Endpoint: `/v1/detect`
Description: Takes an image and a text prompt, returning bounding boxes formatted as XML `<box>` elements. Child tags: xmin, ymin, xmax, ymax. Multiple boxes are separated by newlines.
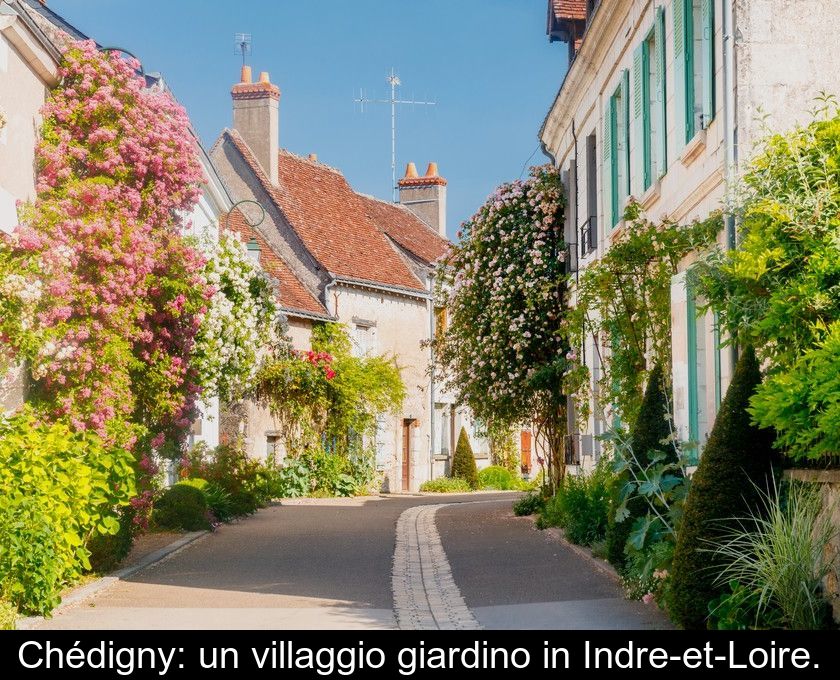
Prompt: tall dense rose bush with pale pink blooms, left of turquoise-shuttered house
<box><xmin>434</xmin><ymin>166</ymin><xmax>569</xmax><ymax>479</ymax></box>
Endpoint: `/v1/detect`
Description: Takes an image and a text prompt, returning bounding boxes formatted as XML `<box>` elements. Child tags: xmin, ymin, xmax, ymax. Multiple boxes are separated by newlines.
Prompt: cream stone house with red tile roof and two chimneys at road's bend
<box><xmin>210</xmin><ymin>67</ymin><xmax>487</xmax><ymax>492</ymax></box>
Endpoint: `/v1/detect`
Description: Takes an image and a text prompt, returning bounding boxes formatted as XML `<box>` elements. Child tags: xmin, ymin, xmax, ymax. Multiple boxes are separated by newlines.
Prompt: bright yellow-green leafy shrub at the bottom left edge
<box><xmin>0</xmin><ymin>409</ymin><xmax>134</xmax><ymax>614</ymax></box>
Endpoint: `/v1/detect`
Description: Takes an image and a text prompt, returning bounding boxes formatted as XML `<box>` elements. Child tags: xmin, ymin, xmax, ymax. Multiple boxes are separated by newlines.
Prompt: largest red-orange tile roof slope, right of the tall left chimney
<box><xmin>225</xmin><ymin>130</ymin><xmax>425</xmax><ymax>291</ymax></box>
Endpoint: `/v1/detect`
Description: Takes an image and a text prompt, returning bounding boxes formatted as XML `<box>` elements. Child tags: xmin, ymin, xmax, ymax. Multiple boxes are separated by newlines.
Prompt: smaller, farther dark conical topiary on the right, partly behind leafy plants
<box><xmin>607</xmin><ymin>365</ymin><xmax>676</xmax><ymax>569</ymax></box>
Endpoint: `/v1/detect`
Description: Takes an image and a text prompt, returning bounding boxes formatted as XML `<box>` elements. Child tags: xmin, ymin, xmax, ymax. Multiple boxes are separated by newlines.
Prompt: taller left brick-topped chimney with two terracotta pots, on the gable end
<box><xmin>230</xmin><ymin>66</ymin><xmax>280</xmax><ymax>184</ymax></box>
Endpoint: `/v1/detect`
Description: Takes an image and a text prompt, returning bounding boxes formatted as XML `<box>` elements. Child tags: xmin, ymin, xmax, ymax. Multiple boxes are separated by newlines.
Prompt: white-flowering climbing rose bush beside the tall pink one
<box><xmin>193</xmin><ymin>231</ymin><xmax>285</xmax><ymax>402</ymax></box>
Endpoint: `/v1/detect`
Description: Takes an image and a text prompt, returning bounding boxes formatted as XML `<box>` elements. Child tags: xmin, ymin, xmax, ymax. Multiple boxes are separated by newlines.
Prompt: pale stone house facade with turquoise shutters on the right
<box><xmin>539</xmin><ymin>0</ymin><xmax>840</xmax><ymax>465</ymax></box>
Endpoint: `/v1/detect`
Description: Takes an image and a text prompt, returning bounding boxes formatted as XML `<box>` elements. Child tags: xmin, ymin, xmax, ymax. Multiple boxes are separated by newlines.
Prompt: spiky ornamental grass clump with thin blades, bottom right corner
<box><xmin>706</xmin><ymin>482</ymin><xmax>837</xmax><ymax>630</ymax></box>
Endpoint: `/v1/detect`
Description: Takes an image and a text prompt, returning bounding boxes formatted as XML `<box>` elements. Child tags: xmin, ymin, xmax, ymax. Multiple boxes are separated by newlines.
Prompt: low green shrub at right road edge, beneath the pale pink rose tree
<box><xmin>540</xmin><ymin>458</ymin><xmax>613</xmax><ymax>545</ymax></box>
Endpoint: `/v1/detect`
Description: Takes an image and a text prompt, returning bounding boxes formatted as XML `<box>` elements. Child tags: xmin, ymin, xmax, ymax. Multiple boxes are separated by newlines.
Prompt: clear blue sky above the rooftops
<box><xmin>49</xmin><ymin>0</ymin><xmax>566</xmax><ymax>236</ymax></box>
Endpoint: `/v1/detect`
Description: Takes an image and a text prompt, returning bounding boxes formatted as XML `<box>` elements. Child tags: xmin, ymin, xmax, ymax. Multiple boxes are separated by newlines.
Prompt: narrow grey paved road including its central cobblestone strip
<box><xmin>41</xmin><ymin>494</ymin><xmax>665</xmax><ymax>629</ymax></box>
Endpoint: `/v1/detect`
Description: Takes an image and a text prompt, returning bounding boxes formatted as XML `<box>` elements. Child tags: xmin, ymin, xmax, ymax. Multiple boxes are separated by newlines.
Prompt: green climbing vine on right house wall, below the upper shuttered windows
<box><xmin>566</xmin><ymin>203</ymin><xmax>721</xmax><ymax>423</ymax></box>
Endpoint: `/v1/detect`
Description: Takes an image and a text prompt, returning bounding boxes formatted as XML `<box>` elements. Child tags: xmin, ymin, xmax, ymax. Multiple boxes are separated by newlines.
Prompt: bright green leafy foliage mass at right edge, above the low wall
<box><xmin>698</xmin><ymin>100</ymin><xmax>840</xmax><ymax>460</ymax></box>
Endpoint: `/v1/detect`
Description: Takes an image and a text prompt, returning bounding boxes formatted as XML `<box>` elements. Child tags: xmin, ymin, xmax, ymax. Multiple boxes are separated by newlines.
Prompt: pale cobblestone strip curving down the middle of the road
<box><xmin>391</xmin><ymin>504</ymin><xmax>481</xmax><ymax>630</ymax></box>
